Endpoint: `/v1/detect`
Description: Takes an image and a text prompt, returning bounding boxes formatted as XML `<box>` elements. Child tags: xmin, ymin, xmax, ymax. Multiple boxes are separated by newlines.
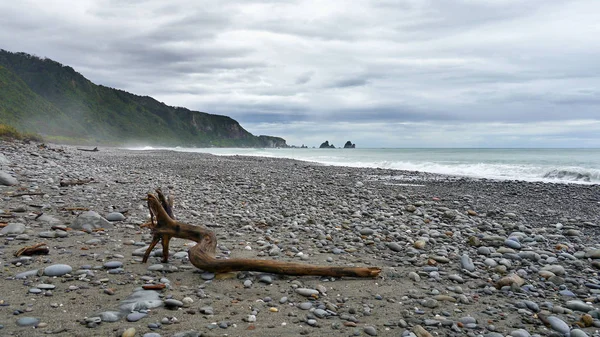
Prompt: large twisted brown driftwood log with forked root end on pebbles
<box><xmin>141</xmin><ymin>189</ymin><xmax>381</xmax><ymax>278</ymax></box>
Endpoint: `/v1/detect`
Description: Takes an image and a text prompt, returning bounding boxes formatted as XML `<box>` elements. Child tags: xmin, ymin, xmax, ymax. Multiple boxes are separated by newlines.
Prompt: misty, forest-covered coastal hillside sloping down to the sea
<box><xmin>0</xmin><ymin>50</ymin><xmax>287</xmax><ymax>147</ymax></box>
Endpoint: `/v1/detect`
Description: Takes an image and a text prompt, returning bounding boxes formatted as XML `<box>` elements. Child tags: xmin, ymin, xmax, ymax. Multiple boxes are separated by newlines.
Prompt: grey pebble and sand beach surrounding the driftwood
<box><xmin>0</xmin><ymin>142</ymin><xmax>600</xmax><ymax>337</ymax></box>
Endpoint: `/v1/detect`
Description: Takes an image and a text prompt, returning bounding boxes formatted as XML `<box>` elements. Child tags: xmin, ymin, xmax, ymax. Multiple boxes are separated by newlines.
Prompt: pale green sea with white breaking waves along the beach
<box><xmin>131</xmin><ymin>147</ymin><xmax>600</xmax><ymax>184</ymax></box>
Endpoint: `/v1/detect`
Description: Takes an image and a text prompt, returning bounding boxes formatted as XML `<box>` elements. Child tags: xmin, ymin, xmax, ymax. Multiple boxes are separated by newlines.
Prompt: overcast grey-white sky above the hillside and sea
<box><xmin>0</xmin><ymin>0</ymin><xmax>600</xmax><ymax>147</ymax></box>
